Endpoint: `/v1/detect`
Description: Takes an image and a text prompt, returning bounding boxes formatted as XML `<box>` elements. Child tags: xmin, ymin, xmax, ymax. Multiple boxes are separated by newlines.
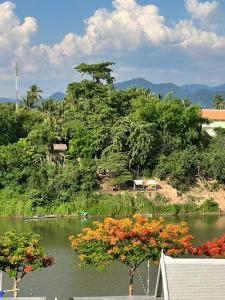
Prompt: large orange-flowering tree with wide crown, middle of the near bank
<box><xmin>69</xmin><ymin>215</ymin><xmax>193</xmax><ymax>295</ymax></box>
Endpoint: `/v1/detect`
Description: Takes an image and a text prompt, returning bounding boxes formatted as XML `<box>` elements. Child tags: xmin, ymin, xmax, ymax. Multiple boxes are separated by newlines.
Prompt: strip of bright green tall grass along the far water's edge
<box><xmin>0</xmin><ymin>189</ymin><xmax>220</xmax><ymax>217</ymax></box>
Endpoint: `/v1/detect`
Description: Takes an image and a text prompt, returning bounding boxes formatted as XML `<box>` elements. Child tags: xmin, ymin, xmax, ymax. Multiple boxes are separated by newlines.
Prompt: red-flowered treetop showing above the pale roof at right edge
<box><xmin>192</xmin><ymin>234</ymin><xmax>225</xmax><ymax>258</ymax></box>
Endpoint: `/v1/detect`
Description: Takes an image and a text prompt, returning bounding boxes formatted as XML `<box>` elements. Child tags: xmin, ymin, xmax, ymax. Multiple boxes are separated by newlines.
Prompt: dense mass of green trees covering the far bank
<box><xmin>0</xmin><ymin>62</ymin><xmax>225</xmax><ymax>216</ymax></box>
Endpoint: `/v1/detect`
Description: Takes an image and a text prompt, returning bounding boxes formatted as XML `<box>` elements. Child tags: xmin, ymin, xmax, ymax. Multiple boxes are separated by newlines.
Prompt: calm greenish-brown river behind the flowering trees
<box><xmin>0</xmin><ymin>216</ymin><xmax>225</xmax><ymax>300</ymax></box>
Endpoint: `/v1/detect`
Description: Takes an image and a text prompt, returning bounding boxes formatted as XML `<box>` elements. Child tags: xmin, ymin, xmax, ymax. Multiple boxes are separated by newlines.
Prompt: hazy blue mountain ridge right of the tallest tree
<box><xmin>115</xmin><ymin>78</ymin><xmax>225</xmax><ymax>108</ymax></box>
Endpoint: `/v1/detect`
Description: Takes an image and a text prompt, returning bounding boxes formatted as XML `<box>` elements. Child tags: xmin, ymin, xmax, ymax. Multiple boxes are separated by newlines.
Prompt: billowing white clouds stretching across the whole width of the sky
<box><xmin>0</xmin><ymin>0</ymin><xmax>225</xmax><ymax>84</ymax></box>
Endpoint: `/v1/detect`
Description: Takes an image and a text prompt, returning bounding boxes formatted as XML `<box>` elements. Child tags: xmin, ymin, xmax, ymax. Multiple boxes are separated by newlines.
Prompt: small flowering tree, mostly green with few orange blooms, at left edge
<box><xmin>0</xmin><ymin>231</ymin><xmax>53</xmax><ymax>298</ymax></box>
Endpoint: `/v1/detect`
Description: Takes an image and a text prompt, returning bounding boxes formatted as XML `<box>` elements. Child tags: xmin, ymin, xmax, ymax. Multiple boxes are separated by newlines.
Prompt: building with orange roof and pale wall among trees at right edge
<box><xmin>202</xmin><ymin>109</ymin><xmax>225</xmax><ymax>136</ymax></box>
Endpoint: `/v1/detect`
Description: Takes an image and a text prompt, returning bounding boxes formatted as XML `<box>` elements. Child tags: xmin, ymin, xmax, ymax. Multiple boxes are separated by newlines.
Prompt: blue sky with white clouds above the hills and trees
<box><xmin>0</xmin><ymin>0</ymin><xmax>225</xmax><ymax>97</ymax></box>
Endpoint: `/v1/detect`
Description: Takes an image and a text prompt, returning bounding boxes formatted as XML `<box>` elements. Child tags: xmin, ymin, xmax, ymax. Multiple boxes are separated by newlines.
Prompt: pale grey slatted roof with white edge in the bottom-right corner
<box><xmin>155</xmin><ymin>253</ymin><xmax>225</xmax><ymax>300</ymax></box>
